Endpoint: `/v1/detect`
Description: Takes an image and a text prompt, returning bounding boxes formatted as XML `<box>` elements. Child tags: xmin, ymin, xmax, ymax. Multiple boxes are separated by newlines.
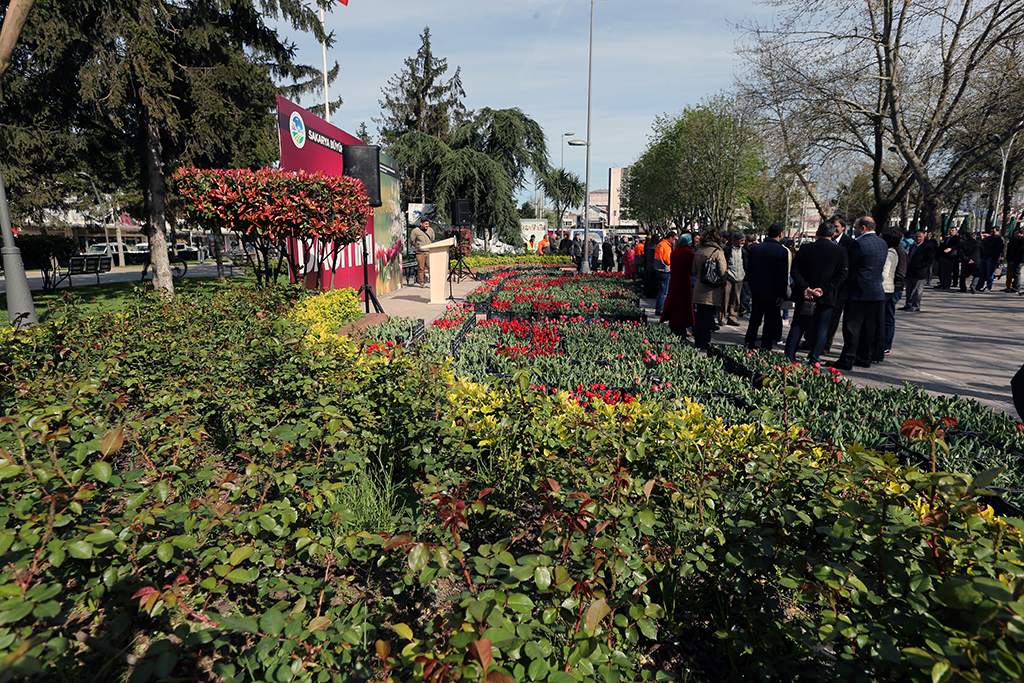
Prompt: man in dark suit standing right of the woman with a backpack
<box><xmin>743</xmin><ymin>223</ymin><xmax>790</xmax><ymax>351</ymax></box>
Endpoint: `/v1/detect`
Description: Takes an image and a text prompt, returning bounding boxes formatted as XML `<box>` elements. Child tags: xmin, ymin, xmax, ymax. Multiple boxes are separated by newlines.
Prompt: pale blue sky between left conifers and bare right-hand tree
<box><xmin>276</xmin><ymin>0</ymin><xmax>769</xmax><ymax>199</ymax></box>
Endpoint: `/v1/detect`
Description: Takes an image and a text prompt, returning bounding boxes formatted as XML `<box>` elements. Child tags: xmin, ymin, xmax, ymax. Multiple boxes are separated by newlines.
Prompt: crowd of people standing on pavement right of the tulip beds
<box><xmin>634</xmin><ymin>216</ymin><xmax>1024</xmax><ymax>371</ymax></box>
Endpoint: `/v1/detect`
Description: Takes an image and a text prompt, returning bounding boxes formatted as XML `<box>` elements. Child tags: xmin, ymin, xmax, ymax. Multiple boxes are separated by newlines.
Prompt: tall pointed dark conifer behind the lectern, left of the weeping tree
<box><xmin>373</xmin><ymin>27</ymin><xmax>468</xmax><ymax>208</ymax></box>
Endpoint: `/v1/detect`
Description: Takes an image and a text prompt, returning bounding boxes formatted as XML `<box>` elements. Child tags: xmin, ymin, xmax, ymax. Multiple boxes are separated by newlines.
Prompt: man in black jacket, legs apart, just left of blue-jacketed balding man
<box><xmin>785</xmin><ymin>222</ymin><xmax>849</xmax><ymax>362</ymax></box>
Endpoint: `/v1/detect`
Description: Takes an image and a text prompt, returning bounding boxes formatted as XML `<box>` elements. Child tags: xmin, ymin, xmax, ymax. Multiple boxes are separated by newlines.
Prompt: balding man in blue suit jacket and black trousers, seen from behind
<box><xmin>833</xmin><ymin>216</ymin><xmax>888</xmax><ymax>371</ymax></box>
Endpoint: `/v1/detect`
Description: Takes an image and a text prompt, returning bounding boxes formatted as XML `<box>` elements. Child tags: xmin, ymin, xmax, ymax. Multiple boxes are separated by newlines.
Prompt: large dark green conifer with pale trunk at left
<box><xmin>2</xmin><ymin>0</ymin><xmax>327</xmax><ymax>294</ymax></box>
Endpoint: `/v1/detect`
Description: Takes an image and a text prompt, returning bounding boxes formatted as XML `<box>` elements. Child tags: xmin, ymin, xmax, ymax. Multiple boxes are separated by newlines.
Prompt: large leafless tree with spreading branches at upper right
<box><xmin>741</xmin><ymin>0</ymin><xmax>1024</xmax><ymax>228</ymax></box>
